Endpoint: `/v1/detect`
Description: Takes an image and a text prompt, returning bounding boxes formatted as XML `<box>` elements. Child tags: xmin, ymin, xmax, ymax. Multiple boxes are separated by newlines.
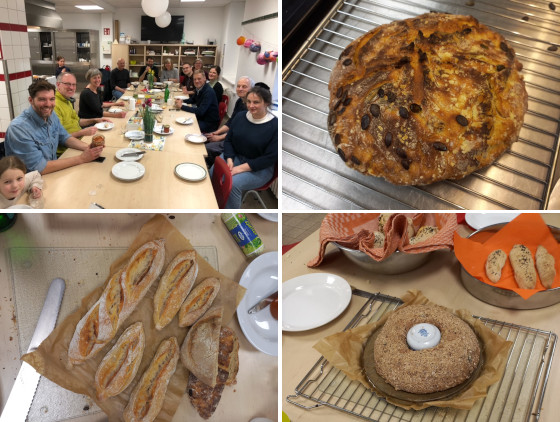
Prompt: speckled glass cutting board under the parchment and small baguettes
<box><xmin>8</xmin><ymin>246</ymin><xmax>218</xmax><ymax>422</ymax></box>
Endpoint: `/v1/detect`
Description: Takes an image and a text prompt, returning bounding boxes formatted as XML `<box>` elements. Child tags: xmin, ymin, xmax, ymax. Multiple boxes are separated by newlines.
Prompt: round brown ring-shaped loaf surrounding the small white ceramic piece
<box><xmin>374</xmin><ymin>305</ymin><xmax>480</xmax><ymax>394</ymax></box>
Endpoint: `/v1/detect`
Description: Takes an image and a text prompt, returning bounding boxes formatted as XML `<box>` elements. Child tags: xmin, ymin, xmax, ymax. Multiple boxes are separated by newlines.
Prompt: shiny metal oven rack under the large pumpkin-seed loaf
<box><xmin>282</xmin><ymin>0</ymin><xmax>560</xmax><ymax>209</ymax></box>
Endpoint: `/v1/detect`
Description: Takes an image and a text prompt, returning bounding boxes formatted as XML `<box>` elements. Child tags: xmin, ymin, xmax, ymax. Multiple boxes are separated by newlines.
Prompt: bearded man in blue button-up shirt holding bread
<box><xmin>4</xmin><ymin>80</ymin><xmax>103</xmax><ymax>174</ymax></box>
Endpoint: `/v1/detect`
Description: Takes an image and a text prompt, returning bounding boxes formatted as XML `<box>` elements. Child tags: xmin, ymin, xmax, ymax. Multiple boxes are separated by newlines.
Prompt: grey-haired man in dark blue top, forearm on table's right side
<box><xmin>175</xmin><ymin>70</ymin><xmax>220</xmax><ymax>133</ymax></box>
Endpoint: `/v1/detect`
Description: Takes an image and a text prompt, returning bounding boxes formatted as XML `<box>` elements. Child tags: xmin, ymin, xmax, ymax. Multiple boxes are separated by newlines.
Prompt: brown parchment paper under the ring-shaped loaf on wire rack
<box><xmin>313</xmin><ymin>290</ymin><xmax>513</xmax><ymax>410</ymax></box>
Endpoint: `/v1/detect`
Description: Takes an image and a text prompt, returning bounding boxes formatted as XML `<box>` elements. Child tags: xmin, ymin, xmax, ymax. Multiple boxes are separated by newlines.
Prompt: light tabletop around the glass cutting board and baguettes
<box><xmin>0</xmin><ymin>213</ymin><xmax>278</xmax><ymax>422</ymax></box>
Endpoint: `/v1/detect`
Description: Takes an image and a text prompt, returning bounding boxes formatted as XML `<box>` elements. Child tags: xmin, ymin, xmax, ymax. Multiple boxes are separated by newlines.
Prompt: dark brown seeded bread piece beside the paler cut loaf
<box><xmin>187</xmin><ymin>327</ymin><xmax>239</xmax><ymax>419</ymax></box>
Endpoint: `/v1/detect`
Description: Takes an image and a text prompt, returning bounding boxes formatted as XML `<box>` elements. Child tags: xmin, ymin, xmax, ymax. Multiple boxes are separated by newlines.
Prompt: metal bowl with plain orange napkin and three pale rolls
<box><xmin>461</xmin><ymin>223</ymin><xmax>560</xmax><ymax>309</ymax></box>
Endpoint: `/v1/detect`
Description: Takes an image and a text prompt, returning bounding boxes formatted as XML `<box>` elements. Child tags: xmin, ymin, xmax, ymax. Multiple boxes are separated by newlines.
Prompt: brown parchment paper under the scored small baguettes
<box><xmin>22</xmin><ymin>215</ymin><xmax>245</xmax><ymax>422</ymax></box>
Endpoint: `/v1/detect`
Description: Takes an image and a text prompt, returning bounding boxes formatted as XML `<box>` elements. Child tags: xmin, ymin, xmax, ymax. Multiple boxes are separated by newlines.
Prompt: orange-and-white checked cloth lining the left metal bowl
<box><xmin>307</xmin><ymin>213</ymin><xmax>457</xmax><ymax>267</ymax></box>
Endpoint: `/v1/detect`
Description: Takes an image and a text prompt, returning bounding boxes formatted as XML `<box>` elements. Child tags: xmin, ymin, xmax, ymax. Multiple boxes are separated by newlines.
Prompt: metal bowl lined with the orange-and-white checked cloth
<box><xmin>333</xmin><ymin>242</ymin><xmax>432</xmax><ymax>274</ymax></box>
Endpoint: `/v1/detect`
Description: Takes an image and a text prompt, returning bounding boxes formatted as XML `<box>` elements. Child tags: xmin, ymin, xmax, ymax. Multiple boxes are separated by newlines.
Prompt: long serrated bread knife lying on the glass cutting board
<box><xmin>0</xmin><ymin>278</ymin><xmax>66</xmax><ymax>422</ymax></box>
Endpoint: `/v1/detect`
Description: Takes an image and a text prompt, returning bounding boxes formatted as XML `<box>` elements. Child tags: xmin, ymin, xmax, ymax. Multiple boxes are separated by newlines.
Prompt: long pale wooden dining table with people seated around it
<box><xmin>19</xmin><ymin>85</ymin><xmax>218</xmax><ymax>209</ymax></box>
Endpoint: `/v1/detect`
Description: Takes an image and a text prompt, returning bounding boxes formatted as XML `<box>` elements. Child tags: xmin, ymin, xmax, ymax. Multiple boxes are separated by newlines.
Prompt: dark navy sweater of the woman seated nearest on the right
<box><xmin>224</xmin><ymin>113</ymin><xmax>278</xmax><ymax>171</ymax></box>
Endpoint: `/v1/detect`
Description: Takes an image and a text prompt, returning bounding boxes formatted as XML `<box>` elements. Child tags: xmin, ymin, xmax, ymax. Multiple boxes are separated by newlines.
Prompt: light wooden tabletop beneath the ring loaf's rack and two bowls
<box><xmin>281</xmin><ymin>214</ymin><xmax>560</xmax><ymax>422</ymax></box>
